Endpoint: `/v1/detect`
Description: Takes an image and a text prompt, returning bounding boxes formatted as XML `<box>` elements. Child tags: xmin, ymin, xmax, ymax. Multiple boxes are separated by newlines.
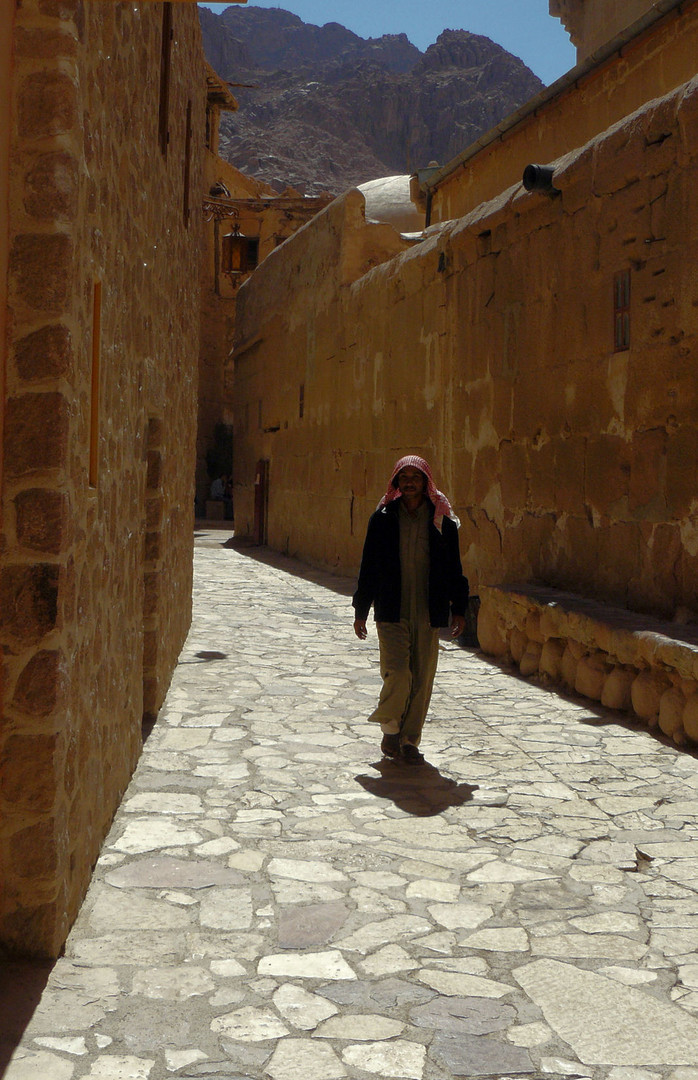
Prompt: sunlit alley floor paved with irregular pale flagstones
<box><xmin>0</xmin><ymin>531</ymin><xmax>698</xmax><ymax>1080</ymax></box>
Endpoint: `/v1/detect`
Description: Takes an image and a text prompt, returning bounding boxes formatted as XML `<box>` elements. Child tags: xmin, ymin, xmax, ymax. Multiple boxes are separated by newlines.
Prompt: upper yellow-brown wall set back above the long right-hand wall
<box><xmin>431</xmin><ymin>4</ymin><xmax>698</xmax><ymax>221</ymax></box>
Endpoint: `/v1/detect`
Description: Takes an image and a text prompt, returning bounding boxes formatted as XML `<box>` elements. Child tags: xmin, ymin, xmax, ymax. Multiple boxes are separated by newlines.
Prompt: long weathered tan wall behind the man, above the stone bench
<box><xmin>236</xmin><ymin>80</ymin><xmax>698</xmax><ymax>617</ymax></box>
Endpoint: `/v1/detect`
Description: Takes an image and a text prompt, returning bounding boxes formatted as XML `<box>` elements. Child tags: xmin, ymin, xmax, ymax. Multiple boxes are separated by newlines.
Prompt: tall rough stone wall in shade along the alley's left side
<box><xmin>0</xmin><ymin>0</ymin><xmax>205</xmax><ymax>956</ymax></box>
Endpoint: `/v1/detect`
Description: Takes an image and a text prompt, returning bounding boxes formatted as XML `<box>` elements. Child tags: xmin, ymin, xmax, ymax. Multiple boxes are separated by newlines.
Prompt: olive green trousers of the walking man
<box><xmin>368</xmin><ymin>619</ymin><xmax>439</xmax><ymax>746</ymax></box>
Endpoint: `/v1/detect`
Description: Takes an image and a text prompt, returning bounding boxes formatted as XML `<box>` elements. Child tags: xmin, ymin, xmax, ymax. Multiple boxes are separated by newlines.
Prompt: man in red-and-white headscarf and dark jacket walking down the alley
<box><xmin>352</xmin><ymin>455</ymin><xmax>468</xmax><ymax>765</ymax></box>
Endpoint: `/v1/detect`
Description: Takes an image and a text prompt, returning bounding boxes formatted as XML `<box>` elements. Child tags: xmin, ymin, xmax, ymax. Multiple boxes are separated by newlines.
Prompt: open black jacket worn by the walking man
<box><xmin>352</xmin><ymin>499</ymin><xmax>468</xmax><ymax>626</ymax></box>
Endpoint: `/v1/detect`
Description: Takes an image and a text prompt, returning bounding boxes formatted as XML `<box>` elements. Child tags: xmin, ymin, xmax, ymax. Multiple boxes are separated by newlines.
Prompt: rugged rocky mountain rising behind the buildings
<box><xmin>199</xmin><ymin>5</ymin><xmax>542</xmax><ymax>194</ymax></box>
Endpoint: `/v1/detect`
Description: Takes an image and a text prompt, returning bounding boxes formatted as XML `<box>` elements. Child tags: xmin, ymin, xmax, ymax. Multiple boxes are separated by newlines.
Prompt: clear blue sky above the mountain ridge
<box><xmin>198</xmin><ymin>0</ymin><xmax>575</xmax><ymax>84</ymax></box>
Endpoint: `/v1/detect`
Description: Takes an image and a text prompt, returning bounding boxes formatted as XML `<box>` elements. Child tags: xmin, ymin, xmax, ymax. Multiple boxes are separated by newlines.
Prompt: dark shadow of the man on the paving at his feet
<box><xmin>354</xmin><ymin>757</ymin><xmax>478</xmax><ymax>818</ymax></box>
